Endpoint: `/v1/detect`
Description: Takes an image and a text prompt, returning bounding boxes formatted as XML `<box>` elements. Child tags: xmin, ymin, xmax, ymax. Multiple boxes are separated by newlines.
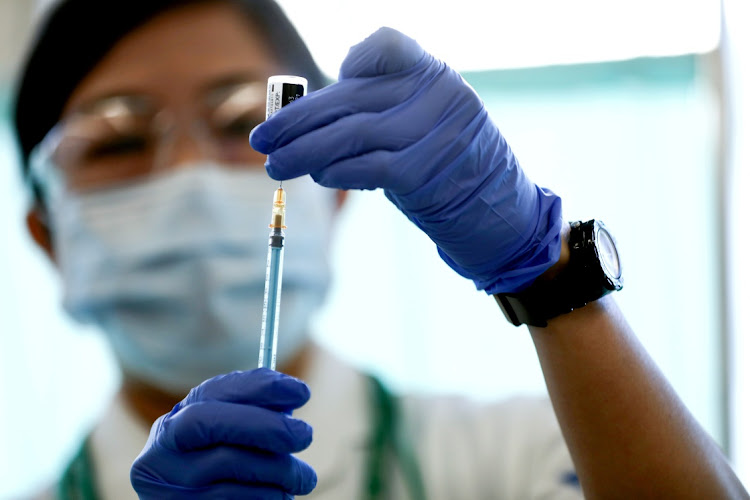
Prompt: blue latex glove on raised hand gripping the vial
<box><xmin>250</xmin><ymin>28</ymin><xmax>562</xmax><ymax>293</ymax></box>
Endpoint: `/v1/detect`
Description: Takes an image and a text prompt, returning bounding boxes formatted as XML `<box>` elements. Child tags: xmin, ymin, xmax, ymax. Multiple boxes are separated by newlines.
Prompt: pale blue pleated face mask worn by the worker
<box><xmin>50</xmin><ymin>165</ymin><xmax>335</xmax><ymax>393</ymax></box>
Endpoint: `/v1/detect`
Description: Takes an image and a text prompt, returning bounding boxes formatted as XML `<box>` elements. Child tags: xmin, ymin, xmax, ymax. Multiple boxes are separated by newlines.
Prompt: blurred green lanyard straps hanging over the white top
<box><xmin>57</xmin><ymin>377</ymin><xmax>427</xmax><ymax>500</ymax></box>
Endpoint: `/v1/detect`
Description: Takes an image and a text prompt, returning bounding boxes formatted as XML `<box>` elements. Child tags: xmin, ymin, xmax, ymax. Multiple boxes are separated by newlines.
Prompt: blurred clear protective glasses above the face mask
<box><xmin>30</xmin><ymin>81</ymin><xmax>266</xmax><ymax>192</ymax></box>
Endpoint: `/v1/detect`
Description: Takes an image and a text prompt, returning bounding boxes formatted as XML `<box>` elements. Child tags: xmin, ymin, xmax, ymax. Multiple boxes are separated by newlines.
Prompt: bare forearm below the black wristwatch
<box><xmin>530</xmin><ymin>297</ymin><xmax>748</xmax><ymax>499</ymax></box>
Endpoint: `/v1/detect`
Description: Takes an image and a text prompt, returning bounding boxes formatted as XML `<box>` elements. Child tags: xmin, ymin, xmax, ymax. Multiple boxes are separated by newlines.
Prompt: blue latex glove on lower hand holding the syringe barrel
<box><xmin>130</xmin><ymin>368</ymin><xmax>317</xmax><ymax>499</ymax></box>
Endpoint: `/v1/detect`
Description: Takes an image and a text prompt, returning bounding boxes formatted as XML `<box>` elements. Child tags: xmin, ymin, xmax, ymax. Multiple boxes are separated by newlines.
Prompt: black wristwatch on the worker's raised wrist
<box><xmin>495</xmin><ymin>220</ymin><xmax>622</xmax><ymax>327</ymax></box>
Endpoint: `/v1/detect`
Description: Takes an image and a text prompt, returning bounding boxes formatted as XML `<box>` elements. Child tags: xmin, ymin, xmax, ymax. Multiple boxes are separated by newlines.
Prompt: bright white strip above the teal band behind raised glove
<box><xmin>278</xmin><ymin>0</ymin><xmax>720</xmax><ymax>76</ymax></box>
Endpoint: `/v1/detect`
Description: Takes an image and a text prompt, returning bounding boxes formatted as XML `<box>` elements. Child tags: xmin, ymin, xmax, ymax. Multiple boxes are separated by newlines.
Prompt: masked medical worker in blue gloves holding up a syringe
<box><xmin>14</xmin><ymin>0</ymin><xmax>747</xmax><ymax>500</ymax></box>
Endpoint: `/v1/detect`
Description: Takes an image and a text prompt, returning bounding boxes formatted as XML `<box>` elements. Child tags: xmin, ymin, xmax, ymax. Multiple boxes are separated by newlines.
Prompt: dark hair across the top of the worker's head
<box><xmin>13</xmin><ymin>0</ymin><xmax>327</xmax><ymax>205</ymax></box>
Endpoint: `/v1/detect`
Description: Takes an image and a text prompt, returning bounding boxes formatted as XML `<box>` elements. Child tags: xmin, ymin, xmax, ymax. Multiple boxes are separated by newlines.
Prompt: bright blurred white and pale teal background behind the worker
<box><xmin>0</xmin><ymin>0</ymin><xmax>750</xmax><ymax>499</ymax></box>
